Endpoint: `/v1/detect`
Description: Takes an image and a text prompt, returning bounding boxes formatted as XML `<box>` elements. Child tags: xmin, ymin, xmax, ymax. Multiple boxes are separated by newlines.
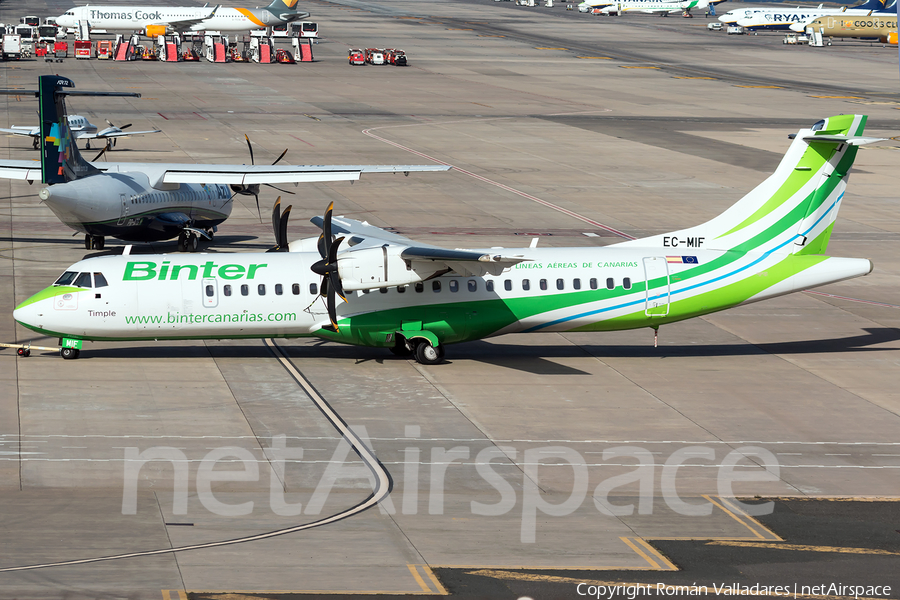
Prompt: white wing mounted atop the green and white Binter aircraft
<box><xmin>310</xmin><ymin>217</ymin><xmax>532</xmax><ymax>277</ymax></box>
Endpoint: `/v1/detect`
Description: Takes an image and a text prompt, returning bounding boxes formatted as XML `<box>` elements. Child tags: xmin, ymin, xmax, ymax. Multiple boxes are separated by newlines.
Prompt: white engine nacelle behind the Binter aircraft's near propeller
<box><xmin>338</xmin><ymin>246</ymin><xmax>445</xmax><ymax>292</ymax></box>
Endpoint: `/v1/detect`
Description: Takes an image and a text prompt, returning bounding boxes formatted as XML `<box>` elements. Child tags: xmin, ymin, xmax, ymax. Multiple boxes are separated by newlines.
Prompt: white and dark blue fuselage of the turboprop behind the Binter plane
<box><xmin>39</xmin><ymin>171</ymin><xmax>232</xmax><ymax>242</ymax></box>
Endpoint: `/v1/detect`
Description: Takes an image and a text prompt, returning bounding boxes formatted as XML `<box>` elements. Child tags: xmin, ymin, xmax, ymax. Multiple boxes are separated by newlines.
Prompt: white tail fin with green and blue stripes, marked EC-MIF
<box><xmin>617</xmin><ymin>115</ymin><xmax>881</xmax><ymax>254</ymax></box>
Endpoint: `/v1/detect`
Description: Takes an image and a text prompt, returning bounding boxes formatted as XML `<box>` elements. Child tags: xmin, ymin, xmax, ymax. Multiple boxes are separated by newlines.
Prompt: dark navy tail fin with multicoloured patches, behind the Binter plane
<box><xmin>37</xmin><ymin>75</ymin><xmax>100</xmax><ymax>184</ymax></box>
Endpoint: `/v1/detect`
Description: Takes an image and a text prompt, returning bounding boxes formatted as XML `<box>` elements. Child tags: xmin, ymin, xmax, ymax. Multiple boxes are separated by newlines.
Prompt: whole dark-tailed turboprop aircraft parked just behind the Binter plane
<box><xmin>0</xmin><ymin>75</ymin><xmax>450</xmax><ymax>251</ymax></box>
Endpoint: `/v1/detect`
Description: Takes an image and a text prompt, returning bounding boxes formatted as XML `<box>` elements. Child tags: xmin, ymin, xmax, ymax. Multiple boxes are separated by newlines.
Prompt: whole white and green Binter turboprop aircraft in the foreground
<box><xmin>14</xmin><ymin>115</ymin><xmax>880</xmax><ymax>364</ymax></box>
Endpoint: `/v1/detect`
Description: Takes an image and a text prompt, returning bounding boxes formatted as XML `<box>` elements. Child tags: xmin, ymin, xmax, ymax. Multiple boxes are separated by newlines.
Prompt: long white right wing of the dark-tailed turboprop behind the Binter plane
<box><xmin>92</xmin><ymin>162</ymin><xmax>450</xmax><ymax>187</ymax></box>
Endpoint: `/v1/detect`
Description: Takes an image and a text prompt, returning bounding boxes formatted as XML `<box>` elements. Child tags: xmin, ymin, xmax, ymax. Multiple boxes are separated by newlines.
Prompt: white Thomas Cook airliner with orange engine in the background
<box><xmin>56</xmin><ymin>0</ymin><xmax>309</xmax><ymax>37</ymax></box>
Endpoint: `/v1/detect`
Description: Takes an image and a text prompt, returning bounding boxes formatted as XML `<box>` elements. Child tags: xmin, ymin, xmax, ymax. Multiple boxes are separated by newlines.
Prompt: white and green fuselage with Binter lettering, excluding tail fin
<box><xmin>14</xmin><ymin>240</ymin><xmax>872</xmax><ymax>346</ymax></box>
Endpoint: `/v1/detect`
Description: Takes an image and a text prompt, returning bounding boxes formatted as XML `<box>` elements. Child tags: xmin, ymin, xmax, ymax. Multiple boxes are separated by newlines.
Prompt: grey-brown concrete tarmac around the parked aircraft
<box><xmin>0</xmin><ymin>0</ymin><xmax>900</xmax><ymax>600</ymax></box>
